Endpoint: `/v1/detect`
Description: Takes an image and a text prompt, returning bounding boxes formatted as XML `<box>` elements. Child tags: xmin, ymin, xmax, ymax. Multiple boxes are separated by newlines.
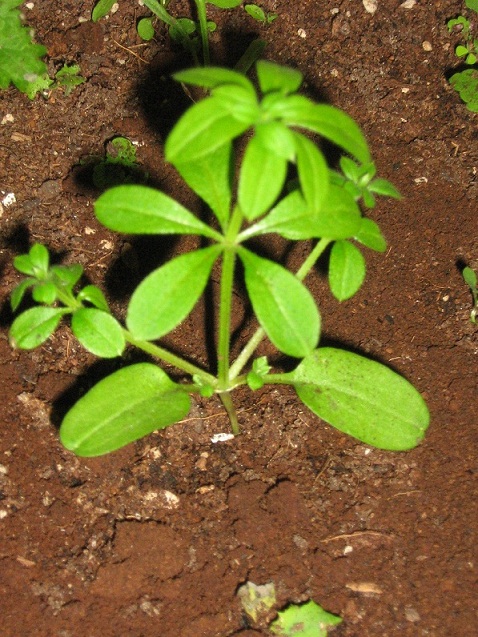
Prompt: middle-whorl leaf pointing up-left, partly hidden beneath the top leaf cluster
<box><xmin>176</xmin><ymin>143</ymin><xmax>232</xmax><ymax>229</ymax></box>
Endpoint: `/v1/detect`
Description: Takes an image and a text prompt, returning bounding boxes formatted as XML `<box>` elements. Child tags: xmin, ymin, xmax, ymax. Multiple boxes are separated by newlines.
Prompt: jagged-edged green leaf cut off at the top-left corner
<box><xmin>0</xmin><ymin>0</ymin><xmax>52</xmax><ymax>99</ymax></box>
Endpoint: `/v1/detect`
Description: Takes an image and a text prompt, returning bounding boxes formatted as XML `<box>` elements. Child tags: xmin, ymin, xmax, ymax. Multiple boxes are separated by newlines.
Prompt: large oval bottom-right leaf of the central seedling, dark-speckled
<box><xmin>287</xmin><ymin>348</ymin><xmax>430</xmax><ymax>451</ymax></box>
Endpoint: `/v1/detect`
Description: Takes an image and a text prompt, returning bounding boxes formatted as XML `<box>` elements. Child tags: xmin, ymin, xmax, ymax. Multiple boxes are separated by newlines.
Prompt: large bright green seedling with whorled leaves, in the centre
<box><xmin>10</xmin><ymin>61</ymin><xmax>429</xmax><ymax>456</ymax></box>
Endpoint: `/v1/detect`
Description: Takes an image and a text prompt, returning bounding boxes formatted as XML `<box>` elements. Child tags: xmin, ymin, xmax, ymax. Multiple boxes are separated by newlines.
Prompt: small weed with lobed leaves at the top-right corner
<box><xmin>447</xmin><ymin>0</ymin><xmax>478</xmax><ymax>113</ymax></box>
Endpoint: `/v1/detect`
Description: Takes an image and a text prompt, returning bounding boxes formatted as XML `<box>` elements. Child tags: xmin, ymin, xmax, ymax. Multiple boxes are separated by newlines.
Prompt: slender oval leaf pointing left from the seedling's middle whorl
<box><xmin>95</xmin><ymin>185</ymin><xmax>218</xmax><ymax>238</ymax></box>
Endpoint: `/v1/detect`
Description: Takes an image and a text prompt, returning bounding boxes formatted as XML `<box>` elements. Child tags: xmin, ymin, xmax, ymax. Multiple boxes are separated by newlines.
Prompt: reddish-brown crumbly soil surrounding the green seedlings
<box><xmin>0</xmin><ymin>0</ymin><xmax>478</xmax><ymax>637</ymax></box>
